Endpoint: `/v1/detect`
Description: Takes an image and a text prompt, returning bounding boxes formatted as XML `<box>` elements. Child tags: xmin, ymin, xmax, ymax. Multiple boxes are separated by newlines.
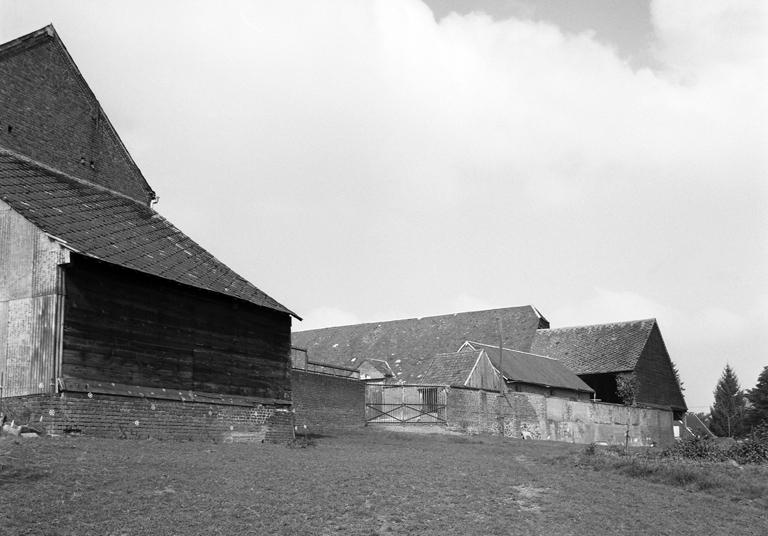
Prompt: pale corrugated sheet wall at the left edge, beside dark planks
<box><xmin>0</xmin><ymin>201</ymin><xmax>66</xmax><ymax>397</ymax></box>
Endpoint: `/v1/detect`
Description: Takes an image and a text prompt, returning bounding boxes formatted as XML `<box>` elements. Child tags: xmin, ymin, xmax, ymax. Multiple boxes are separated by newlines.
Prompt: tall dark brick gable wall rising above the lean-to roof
<box><xmin>0</xmin><ymin>33</ymin><xmax>152</xmax><ymax>203</ymax></box>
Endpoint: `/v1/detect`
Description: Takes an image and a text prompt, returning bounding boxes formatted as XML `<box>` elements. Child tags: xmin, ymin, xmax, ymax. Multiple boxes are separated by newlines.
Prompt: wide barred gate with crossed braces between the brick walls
<box><xmin>365</xmin><ymin>385</ymin><xmax>447</xmax><ymax>424</ymax></box>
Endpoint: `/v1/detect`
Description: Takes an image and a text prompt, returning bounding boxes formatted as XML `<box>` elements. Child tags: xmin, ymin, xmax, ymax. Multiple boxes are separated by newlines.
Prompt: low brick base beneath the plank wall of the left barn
<box><xmin>2</xmin><ymin>393</ymin><xmax>293</xmax><ymax>443</ymax></box>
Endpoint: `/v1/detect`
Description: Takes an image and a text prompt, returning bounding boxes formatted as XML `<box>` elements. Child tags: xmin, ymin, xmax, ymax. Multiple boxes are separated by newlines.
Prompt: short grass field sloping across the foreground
<box><xmin>0</xmin><ymin>430</ymin><xmax>768</xmax><ymax>536</ymax></box>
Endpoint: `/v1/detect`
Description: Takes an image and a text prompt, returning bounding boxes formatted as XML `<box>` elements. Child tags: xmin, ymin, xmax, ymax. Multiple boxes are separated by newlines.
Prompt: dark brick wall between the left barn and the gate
<box><xmin>291</xmin><ymin>370</ymin><xmax>365</xmax><ymax>433</ymax></box>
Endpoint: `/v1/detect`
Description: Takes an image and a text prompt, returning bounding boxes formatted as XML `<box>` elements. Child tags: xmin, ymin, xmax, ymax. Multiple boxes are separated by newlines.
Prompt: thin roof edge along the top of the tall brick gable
<box><xmin>0</xmin><ymin>24</ymin><xmax>157</xmax><ymax>204</ymax></box>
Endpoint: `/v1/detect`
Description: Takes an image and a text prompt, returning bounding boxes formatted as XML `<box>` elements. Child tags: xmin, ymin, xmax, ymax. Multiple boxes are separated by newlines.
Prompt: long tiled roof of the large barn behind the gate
<box><xmin>293</xmin><ymin>305</ymin><xmax>548</xmax><ymax>382</ymax></box>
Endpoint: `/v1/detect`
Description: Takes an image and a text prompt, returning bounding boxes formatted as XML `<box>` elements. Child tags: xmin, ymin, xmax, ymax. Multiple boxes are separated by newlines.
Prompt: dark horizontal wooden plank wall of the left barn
<box><xmin>62</xmin><ymin>255</ymin><xmax>291</xmax><ymax>399</ymax></box>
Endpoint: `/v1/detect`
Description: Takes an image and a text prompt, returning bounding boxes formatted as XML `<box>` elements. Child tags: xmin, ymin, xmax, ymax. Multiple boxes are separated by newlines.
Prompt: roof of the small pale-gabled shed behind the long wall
<box><xmin>468</xmin><ymin>341</ymin><xmax>594</xmax><ymax>393</ymax></box>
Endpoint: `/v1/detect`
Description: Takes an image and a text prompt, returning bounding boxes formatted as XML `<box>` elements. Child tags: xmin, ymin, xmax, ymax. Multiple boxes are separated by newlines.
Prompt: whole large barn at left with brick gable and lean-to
<box><xmin>0</xmin><ymin>26</ymin><xmax>298</xmax><ymax>440</ymax></box>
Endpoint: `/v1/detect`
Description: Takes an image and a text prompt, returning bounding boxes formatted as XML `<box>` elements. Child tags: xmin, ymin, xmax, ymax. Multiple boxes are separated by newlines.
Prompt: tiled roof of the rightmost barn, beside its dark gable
<box><xmin>530</xmin><ymin>318</ymin><xmax>656</xmax><ymax>374</ymax></box>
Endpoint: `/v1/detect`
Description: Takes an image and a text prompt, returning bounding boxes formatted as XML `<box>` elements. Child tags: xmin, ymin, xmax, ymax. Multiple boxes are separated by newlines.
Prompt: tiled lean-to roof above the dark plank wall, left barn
<box><xmin>0</xmin><ymin>149</ymin><xmax>298</xmax><ymax>318</ymax></box>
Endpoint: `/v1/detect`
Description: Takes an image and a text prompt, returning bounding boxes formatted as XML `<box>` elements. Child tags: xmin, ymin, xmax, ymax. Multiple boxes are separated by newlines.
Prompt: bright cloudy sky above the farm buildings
<box><xmin>0</xmin><ymin>0</ymin><xmax>768</xmax><ymax>411</ymax></box>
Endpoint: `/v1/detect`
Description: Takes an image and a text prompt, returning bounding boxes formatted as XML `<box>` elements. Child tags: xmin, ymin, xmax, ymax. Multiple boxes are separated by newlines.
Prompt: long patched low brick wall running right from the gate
<box><xmin>447</xmin><ymin>389</ymin><xmax>674</xmax><ymax>446</ymax></box>
